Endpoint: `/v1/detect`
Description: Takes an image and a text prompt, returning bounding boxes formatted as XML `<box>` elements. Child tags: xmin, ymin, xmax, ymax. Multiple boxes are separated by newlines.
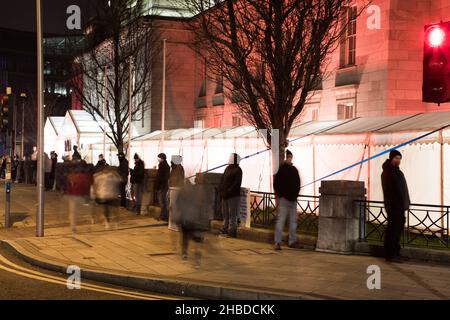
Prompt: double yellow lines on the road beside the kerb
<box><xmin>0</xmin><ymin>255</ymin><xmax>176</xmax><ymax>300</ymax></box>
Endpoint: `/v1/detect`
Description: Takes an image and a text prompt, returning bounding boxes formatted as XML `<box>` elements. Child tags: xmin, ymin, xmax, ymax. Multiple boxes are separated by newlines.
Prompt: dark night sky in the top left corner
<box><xmin>0</xmin><ymin>0</ymin><xmax>97</xmax><ymax>34</ymax></box>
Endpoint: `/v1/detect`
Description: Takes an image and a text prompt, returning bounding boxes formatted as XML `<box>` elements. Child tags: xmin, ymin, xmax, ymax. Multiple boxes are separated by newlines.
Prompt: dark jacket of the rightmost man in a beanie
<box><xmin>381</xmin><ymin>159</ymin><xmax>410</xmax><ymax>210</ymax></box>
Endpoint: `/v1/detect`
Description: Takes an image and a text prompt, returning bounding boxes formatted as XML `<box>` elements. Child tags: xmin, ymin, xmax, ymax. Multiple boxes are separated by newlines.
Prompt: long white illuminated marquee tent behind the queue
<box><xmin>45</xmin><ymin>110</ymin><xmax>450</xmax><ymax>205</ymax></box>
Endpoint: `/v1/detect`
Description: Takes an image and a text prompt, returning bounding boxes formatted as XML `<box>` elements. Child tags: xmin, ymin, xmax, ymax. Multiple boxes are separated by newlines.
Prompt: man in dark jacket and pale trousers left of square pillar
<box><xmin>273</xmin><ymin>150</ymin><xmax>300</xmax><ymax>250</ymax></box>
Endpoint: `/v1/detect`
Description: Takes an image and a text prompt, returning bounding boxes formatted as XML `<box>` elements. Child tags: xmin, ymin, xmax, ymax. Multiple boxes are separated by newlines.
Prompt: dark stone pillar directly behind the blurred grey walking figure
<box><xmin>195</xmin><ymin>172</ymin><xmax>222</xmax><ymax>220</ymax></box>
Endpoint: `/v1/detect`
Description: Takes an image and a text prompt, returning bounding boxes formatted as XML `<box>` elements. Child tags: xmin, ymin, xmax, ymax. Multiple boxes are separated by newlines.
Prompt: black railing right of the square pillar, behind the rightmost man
<box><xmin>356</xmin><ymin>201</ymin><xmax>450</xmax><ymax>249</ymax></box>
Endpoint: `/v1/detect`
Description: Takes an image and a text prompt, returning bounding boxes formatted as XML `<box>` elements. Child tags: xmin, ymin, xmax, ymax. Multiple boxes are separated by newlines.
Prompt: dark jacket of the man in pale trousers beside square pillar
<box><xmin>273</xmin><ymin>163</ymin><xmax>300</xmax><ymax>201</ymax></box>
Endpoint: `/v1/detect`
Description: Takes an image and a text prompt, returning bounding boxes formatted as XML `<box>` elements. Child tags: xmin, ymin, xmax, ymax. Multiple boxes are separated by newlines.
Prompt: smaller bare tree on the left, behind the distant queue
<box><xmin>72</xmin><ymin>0</ymin><xmax>160</xmax><ymax>152</ymax></box>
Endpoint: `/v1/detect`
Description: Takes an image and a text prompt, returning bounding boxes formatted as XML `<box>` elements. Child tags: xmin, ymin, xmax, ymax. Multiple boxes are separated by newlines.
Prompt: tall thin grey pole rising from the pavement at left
<box><xmin>36</xmin><ymin>0</ymin><xmax>44</xmax><ymax>237</ymax></box>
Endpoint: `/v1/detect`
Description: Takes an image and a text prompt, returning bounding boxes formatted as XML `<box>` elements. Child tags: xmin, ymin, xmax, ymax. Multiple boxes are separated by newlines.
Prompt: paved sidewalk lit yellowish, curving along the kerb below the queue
<box><xmin>0</xmin><ymin>184</ymin><xmax>450</xmax><ymax>300</ymax></box>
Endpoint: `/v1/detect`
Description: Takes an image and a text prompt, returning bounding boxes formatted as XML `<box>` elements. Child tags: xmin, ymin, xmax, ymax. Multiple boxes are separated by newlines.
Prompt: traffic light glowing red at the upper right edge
<box><xmin>422</xmin><ymin>22</ymin><xmax>450</xmax><ymax>104</ymax></box>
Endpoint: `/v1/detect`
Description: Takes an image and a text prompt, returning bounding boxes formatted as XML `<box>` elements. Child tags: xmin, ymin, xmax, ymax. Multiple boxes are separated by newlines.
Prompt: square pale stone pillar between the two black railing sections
<box><xmin>316</xmin><ymin>180</ymin><xmax>366</xmax><ymax>254</ymax></box>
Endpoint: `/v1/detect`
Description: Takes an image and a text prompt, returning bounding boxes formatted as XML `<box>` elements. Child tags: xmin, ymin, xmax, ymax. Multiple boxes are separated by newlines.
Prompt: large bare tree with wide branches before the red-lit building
<box><xmin>182</xmin><ymin>0</ymin><xmax>366</xmax><ymax>165</ymax></box>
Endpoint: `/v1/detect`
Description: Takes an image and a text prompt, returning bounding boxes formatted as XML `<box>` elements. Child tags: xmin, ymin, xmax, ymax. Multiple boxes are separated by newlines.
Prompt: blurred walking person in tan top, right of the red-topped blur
<box><xmin>92</xmin><ymin>166</ymin><xmax>122</xmax><ymax>229</ymax></box>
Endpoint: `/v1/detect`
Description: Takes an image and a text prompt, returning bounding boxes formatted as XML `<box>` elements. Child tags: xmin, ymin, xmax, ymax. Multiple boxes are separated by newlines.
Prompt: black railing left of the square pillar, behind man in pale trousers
<box><xmin>250</xmin><ymin>191</ymin><xmax>319</xmax><ymax>235</ymax></box>
